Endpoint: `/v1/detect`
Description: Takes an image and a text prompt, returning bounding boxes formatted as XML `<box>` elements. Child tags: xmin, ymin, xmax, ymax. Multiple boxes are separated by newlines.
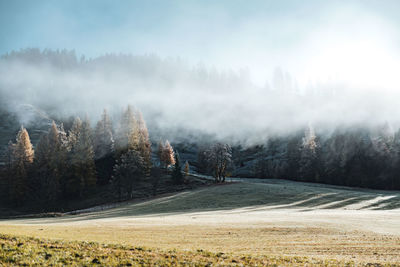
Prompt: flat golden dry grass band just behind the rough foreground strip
<box><xmin>0</xmin><ymin>225</ymin><xmax>400</xmax><ymax>264</ymax></box>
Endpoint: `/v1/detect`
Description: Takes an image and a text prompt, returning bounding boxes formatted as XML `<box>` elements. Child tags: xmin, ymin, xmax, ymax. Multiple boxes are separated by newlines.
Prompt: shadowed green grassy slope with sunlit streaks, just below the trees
<box><xmin>19</xmin><ymin>181</ymin><xmax>400</xmax><ymax>223</ymax></box>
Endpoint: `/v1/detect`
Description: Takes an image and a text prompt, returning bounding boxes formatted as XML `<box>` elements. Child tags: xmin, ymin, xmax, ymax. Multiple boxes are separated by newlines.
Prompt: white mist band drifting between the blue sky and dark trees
<box><xmin>0</xmin><ymin>49</ymin><xmax>400</xmax><ymax>142</ymax></box>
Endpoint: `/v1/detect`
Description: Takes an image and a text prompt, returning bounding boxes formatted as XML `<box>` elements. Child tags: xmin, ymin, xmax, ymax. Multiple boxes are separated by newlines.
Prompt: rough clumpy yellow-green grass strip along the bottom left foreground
<box><xmin>0</xmin><ymin>234</ymin><xmax>362</xmax><ymax>266</ymax></box>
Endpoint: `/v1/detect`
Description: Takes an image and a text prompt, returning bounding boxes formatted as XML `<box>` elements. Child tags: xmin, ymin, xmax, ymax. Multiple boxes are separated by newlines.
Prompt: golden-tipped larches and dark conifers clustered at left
<box><xmin>1</xmin><ymin>106</ymin><xmax>188</xmax><ymax>208</ymax></box>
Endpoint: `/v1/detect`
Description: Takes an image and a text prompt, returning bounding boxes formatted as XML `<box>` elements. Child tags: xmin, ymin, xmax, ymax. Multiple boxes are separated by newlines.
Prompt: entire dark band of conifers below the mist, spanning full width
<box><xmin>1</xmin><ymin>106</ymin><xmax>400</xmax><ymax>209</ymax></box>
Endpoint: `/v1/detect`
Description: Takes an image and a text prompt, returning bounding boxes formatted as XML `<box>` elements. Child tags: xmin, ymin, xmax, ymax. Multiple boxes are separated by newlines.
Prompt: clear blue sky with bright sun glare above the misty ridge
<box><xmin>0</xmin><ymin>0</ymin><xmax>400</xmax><ymax>87</ymax></box>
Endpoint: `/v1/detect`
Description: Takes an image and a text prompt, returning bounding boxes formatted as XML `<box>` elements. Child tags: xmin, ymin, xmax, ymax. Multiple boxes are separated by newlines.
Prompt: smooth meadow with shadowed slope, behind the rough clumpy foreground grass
<box><xmin>0</xmin><ymin>180</ymin><xmax>400</xmax><ymax>265</ymax></box>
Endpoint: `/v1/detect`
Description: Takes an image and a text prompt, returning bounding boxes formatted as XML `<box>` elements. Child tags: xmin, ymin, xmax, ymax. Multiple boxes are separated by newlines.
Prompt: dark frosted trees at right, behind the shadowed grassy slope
<box><xmin>254</xmin><ymin>125</ymin><xmax>400</xmax><ymax>190</ymax></box>
